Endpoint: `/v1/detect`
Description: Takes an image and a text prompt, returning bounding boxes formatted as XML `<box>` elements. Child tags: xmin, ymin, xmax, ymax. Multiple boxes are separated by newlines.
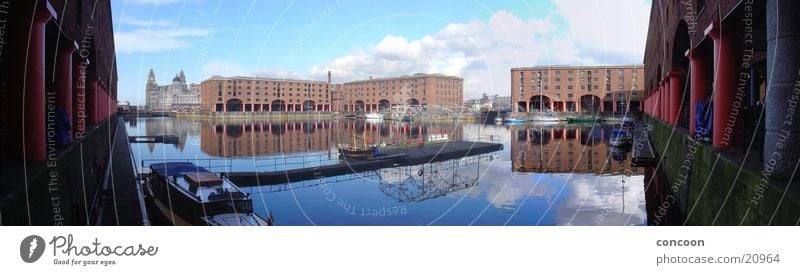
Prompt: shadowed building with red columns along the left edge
<box><xmin>0</xmin><ymin>0</ymin><xmax>120</xmax><ymax>225</ymax></box>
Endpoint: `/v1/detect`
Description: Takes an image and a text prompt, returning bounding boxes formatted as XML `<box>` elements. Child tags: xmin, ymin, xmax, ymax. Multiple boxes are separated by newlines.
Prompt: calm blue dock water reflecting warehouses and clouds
<box><xmin>127</xmin><ymin>118</ymin><xmax>647</xmax><ymax>225</ymax></box>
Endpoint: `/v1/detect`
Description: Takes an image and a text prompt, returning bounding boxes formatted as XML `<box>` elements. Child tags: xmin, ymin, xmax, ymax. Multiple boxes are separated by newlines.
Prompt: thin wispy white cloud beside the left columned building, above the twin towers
<box><xmin>114</xmin><ymin>28</ymin><xmax>211</xmax><ymax>54</ymax></box>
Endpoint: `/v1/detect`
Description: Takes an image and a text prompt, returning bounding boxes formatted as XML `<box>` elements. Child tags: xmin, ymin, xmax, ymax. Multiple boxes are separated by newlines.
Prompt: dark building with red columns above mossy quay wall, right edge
<box><xmin>643</xmin><ymin>0</ymin><xmax>800</xmax><ymax>225</ymax></box>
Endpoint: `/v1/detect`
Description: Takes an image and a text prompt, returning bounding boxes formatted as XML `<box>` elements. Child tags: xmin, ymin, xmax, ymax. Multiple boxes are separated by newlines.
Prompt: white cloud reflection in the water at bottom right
<box><xmin>551</xmin><ymin>174</ymin><xmax>647</xmax><ymax>225</ymax></box>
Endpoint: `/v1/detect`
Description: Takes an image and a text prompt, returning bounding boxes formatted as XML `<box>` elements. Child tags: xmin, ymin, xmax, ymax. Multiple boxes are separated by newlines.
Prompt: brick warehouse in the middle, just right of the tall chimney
<box><xmin>336</xmin><ymin>74</ymin><xmax>464</xmax><ymax>112</ymax></box>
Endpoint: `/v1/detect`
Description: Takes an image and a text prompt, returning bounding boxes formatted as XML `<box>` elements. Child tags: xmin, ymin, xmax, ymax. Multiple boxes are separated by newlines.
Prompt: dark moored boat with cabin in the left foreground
<box><xmin>146</xmin><ymin>162</ymin><xmax>273</xmax><ymax>226</ymax></box>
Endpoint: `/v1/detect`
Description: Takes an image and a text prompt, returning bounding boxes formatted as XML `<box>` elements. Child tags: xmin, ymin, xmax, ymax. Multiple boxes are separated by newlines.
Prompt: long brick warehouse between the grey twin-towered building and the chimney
<box><xmin>200</xmin><ymin>75</ymin><xmax>332</xmax><ymax>112</ymax></box>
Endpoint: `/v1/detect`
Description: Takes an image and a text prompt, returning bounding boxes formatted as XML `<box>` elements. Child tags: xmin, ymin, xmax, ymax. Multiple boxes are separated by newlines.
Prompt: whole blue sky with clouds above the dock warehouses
<box><xmin>112</xmin><ymin>0</ymin><xmax>650</xmax><ymax>104</ymax></box>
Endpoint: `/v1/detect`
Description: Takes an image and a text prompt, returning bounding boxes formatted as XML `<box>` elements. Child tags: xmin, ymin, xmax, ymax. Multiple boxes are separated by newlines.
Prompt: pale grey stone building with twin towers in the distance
<box><xmin>145</xmin><ymin>69</ymin><xmax>200</xmax><ymax>111</ymax></box>
